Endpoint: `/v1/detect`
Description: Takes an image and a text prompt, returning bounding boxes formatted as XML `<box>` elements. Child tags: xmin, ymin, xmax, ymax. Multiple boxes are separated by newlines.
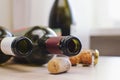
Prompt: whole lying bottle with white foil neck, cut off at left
<box><xmin>0</xmin><ymin>27</ymin><xmax>32</xmax><ymax>64</ymax></box>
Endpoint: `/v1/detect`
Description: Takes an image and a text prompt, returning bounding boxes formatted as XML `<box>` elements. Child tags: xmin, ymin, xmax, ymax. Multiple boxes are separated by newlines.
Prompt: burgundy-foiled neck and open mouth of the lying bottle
<box><xmin>45</xmin><ymin>36</ymin><xmax>82</xmax><ymax>56</ymax></box>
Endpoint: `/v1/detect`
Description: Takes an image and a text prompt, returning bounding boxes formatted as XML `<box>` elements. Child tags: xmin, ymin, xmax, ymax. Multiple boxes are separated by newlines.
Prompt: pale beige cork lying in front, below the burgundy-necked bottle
<box><xmin>48</xmin><ymin>57</ymin><xmax>71</xmax><ymax>74</ymax></box>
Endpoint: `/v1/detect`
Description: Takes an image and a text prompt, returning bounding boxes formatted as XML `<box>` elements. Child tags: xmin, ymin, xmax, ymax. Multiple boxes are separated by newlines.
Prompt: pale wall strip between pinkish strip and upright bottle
<box><xmin>30</xmin><ymin>0</ymin><xmax>54</xmax><ymax>26</ymax></box>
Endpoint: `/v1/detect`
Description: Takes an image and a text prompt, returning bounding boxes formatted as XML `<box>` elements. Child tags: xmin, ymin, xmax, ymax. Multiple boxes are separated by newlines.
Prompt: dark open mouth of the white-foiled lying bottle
<box><xmin>12</xmin><ymin>37</ymin><xmax>33</xmax><ymax>57</ymax></box>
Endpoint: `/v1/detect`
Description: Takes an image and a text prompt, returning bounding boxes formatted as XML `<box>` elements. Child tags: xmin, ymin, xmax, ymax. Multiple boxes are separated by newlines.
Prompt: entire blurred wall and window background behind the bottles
<box><xmin>0</xmin><ymin>0</ymin><xmax>120</xmax><ymax>56</ymax></box>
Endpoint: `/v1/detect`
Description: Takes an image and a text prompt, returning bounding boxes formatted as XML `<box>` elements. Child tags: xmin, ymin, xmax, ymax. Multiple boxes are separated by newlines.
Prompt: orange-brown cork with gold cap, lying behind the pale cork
<box><xmin>69</xmin><ymin>49</ymin><xmax>99</xmax><ymax>66</ymax></box>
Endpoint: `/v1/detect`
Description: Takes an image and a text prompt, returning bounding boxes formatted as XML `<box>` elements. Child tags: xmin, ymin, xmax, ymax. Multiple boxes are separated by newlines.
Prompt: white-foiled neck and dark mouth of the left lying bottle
<box><xmin>1</xmin><ymin>37</ymin><xmax>32</xmax><ymax>57</ymax></box>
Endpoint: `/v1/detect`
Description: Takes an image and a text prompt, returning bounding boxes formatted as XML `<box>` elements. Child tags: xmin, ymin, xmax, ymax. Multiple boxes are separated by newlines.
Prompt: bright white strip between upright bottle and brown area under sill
<box><xmin>69</xmin><ymin>0</ymin><xmax>93</xmax><ymax>48</ymax></box>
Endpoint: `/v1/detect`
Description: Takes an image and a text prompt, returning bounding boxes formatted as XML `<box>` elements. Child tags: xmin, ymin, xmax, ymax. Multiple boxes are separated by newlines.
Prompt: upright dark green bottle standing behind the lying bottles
<box><xmin>49</xmin><ymin>0</ymin><xmax>72</xmax><ymax>36</ymax></box>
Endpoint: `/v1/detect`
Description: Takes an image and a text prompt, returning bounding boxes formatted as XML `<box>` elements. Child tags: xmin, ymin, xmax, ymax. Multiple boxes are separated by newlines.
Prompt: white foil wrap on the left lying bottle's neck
<box><xmin>1</xmin><ymin>37</ymin><xmax>16</xmax><ymax>56</ymax></box>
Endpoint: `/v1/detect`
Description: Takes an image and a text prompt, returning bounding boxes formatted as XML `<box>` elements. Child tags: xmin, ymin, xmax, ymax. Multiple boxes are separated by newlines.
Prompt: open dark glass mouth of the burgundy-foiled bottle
<box><xmin>63</xmin><ymin>36</ymin><xmax>82</xmax><ymax>56</ymax></box>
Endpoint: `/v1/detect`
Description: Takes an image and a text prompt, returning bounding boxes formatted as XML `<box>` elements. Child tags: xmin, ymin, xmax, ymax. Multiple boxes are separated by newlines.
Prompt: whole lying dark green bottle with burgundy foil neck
<box><xmin>13</xmin><ymin>26</ymin><xmax>82</xmax><ymax>65</ymax></box>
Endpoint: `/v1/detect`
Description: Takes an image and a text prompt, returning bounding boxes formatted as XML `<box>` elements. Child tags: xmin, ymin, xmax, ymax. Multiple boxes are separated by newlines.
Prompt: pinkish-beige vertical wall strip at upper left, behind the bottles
<box><xmin>13</xmin><ymin>0</ymin><xmax>31</xmax><ymax>29</ymax></box>
